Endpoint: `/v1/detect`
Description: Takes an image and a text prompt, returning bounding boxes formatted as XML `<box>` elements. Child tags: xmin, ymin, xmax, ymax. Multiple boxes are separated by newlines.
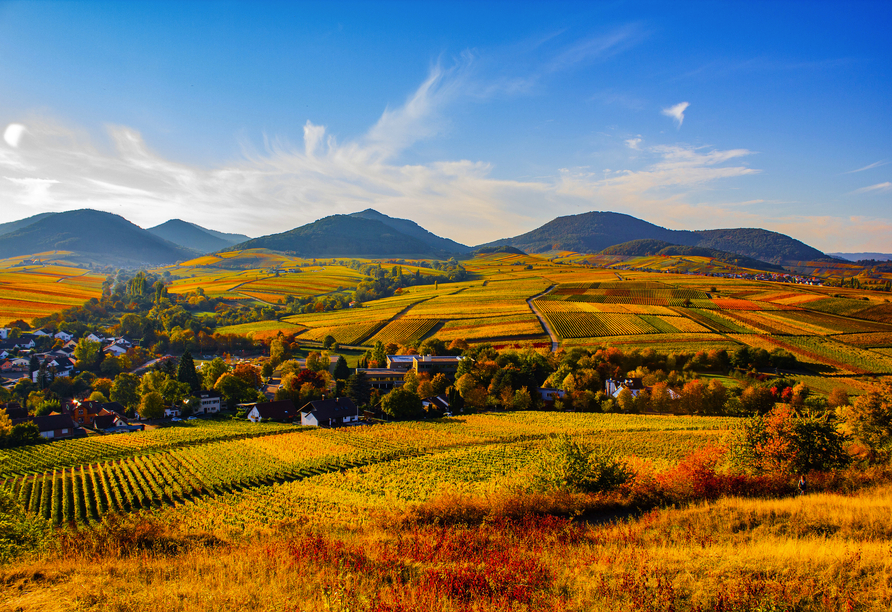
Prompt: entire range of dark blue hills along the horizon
<box><xmin>0</xmin><ymin>209</ymin><xmax>840</xmax><ymax>269</ymax></box>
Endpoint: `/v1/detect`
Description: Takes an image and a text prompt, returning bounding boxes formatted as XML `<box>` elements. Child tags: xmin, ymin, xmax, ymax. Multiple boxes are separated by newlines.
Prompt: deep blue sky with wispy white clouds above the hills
<box><xmin>0</xmin><ymin>0</ymin><xmax>892</xmax><ymax>253</ymax></box>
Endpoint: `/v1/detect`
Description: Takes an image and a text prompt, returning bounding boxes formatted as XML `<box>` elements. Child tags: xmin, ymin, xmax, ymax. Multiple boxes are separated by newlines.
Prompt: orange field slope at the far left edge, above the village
<box><xmin>0</xmin><ymin>253</ymin><xmax>105</xmax><ymax>326</ymax></box>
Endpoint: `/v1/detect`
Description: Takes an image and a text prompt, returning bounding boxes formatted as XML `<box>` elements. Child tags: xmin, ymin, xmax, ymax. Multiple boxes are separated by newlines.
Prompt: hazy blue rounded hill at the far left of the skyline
<box><xmin>0</xmin><ymin>209</ymin><xmax>195</xmax><ymax>266</ymax></box>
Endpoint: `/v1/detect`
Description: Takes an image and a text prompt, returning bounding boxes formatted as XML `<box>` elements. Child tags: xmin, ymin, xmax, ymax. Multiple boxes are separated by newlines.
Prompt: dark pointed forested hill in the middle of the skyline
<box><xmin>224</xmin><ymin>215</ymin><xmax>452</xmax><ymax>257</ymax></box>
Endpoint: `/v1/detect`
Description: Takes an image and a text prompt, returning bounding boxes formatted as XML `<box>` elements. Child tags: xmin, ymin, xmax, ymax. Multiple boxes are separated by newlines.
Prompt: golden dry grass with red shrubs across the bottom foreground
<box><xmin>0</xmin><ymin>485</ymin><xmax>892</xmax><ymax>611</ymax></box>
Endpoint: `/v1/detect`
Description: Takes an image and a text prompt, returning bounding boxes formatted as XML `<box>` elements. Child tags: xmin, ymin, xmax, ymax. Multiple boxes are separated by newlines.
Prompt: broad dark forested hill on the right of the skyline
<box><xmin>478</xmin><ymin>211</ymin><xmax>830</xmax><ymax>264</ymax></box>
